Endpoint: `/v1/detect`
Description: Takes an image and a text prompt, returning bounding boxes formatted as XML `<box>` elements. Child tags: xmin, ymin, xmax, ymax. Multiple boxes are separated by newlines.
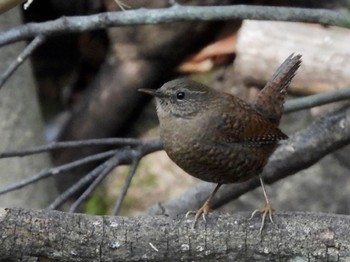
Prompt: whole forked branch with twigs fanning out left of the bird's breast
<box><xmin>0</xmin><ymin>138</ymin><xmax>162</xmax><ymax>211</ymax></box>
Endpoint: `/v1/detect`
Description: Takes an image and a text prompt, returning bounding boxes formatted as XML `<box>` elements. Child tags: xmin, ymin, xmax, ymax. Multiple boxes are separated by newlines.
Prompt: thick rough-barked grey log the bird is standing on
<box><xmin>0</xmin><ymin>208</ymin><xmax>350</xmax><ymax>262</ymax></box>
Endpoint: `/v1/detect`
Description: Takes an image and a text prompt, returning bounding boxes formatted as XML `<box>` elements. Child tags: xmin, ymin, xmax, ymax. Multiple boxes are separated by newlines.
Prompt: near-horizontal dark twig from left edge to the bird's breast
<box><xmin>0</xmin><ymin>138</ymin><xmax>161</xmax><ymax>158</ymax></box>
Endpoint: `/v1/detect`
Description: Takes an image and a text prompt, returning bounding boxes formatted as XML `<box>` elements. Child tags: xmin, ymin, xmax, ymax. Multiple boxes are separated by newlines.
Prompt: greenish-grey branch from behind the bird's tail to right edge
<box><xmin>284</xmin><ymin>88</ymin><xmax>350</xmax><ymax>113</ymax></box>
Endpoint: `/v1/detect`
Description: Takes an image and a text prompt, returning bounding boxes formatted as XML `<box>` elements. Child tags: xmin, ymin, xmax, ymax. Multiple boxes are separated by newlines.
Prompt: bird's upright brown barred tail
<box><xmin>253</xmin><ymin>54</ymin><xmax>301</xmax><ymax>125</ymax></box>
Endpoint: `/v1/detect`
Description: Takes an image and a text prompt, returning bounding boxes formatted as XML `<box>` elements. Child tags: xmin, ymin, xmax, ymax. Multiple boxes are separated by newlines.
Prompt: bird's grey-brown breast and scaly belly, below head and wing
<box><xmin>161</xmin><ymin>114</ymin><xmax>276</xmax><ymax>184</ymax></box>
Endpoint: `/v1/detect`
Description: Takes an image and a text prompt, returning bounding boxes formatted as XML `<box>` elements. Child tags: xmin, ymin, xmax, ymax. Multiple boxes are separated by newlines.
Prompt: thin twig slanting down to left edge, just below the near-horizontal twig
<box><xmin>0</xmin><ymin>150</ymin><xmax>117</xmax><ymax>195</ymax></box>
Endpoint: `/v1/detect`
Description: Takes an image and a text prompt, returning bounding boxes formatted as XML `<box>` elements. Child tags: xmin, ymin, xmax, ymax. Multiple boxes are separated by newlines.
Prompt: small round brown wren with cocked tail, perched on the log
<box><xmin>139</xmin><ymin>55</ymin><xmax>301</xmax><ymax>232</ymax></box>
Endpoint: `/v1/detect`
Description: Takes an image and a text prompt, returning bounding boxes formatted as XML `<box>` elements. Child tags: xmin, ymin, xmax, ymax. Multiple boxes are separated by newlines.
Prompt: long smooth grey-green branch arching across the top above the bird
<box><xmin>0</xmin><ymin>5</ymin><xmax>350</xmax><ymax>46</ymax></box>
